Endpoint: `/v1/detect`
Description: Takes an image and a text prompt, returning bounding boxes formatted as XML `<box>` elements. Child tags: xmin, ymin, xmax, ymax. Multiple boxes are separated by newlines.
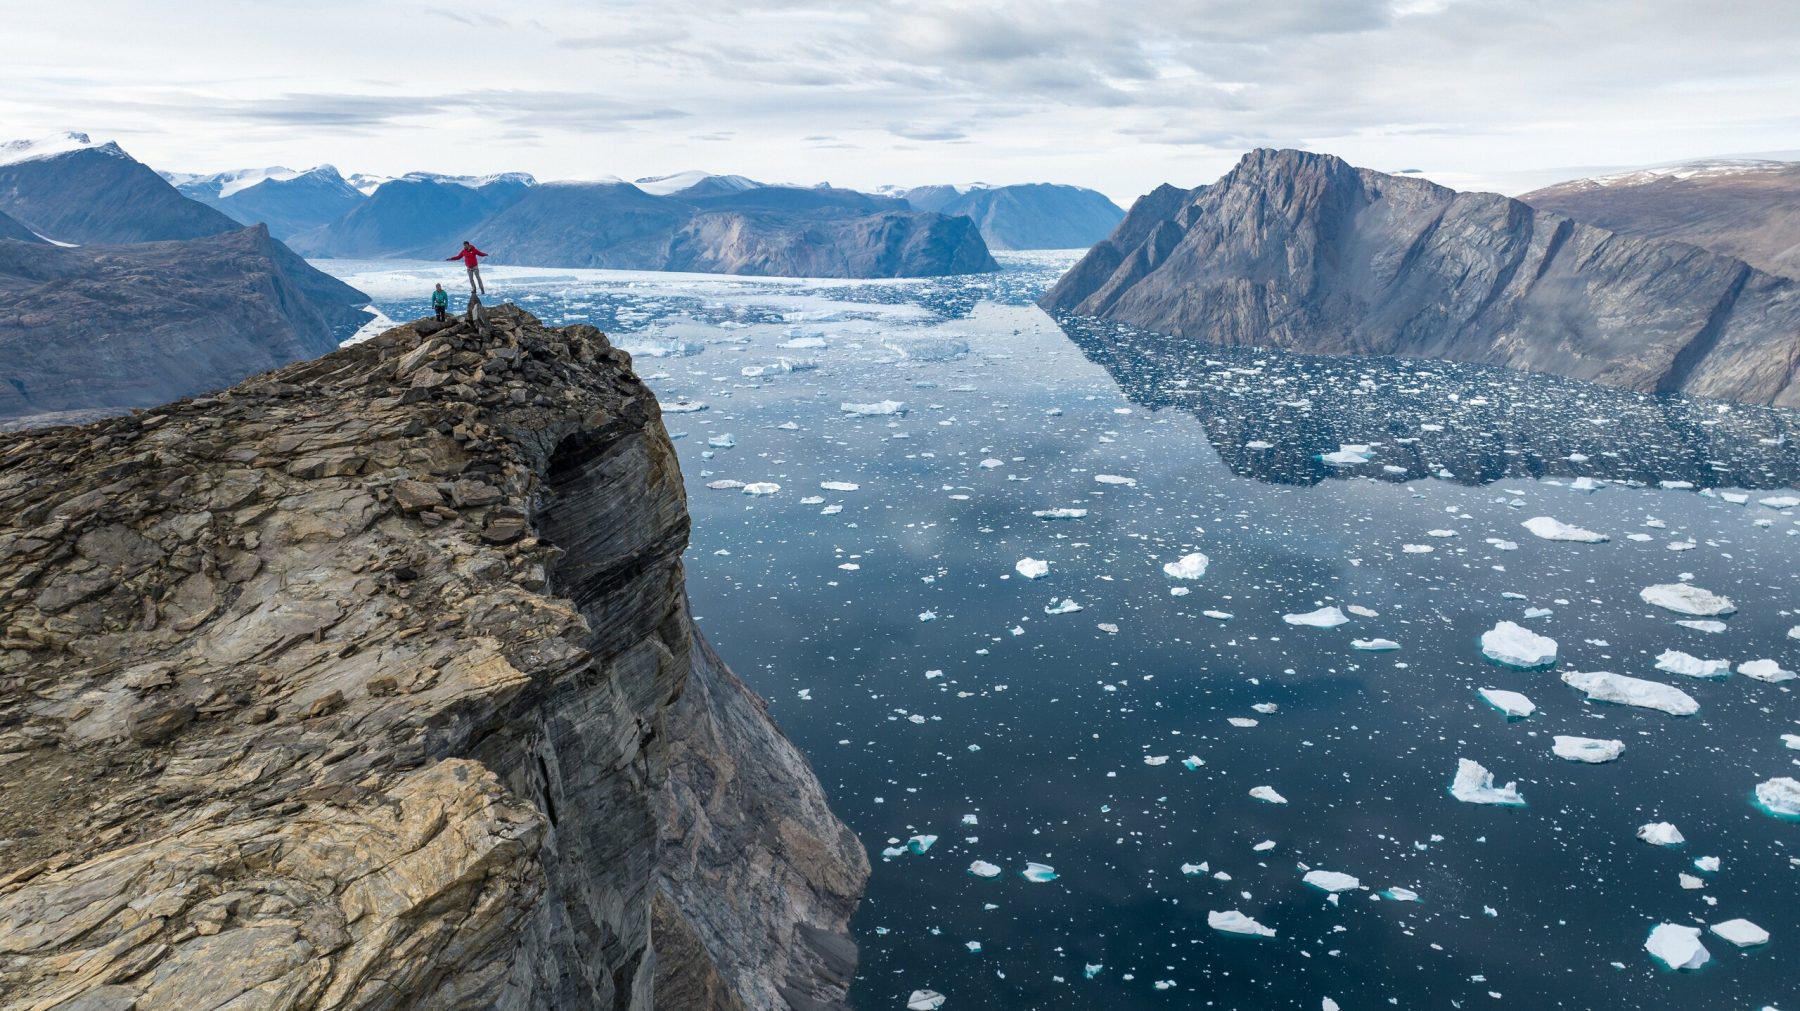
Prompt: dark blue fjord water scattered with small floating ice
<box><xmin>319</xmin><ymin>254</ymin><xmax>1800</xmax><ymax>1011</ymax></box>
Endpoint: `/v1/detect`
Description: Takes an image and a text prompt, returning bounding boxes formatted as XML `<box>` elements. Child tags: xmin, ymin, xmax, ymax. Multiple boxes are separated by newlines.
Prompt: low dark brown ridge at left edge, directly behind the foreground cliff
<box><xmin>0</xmin><ymin>225</ymin><xmax>369</xmax><ymax>426</ymax></box>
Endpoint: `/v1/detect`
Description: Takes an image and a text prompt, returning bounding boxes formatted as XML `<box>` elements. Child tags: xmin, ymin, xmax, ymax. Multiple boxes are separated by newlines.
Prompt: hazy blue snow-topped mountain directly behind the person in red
<box><xmin>292</xmin><ymin>173</ymin><xmax>535</xmax><ymax>259</ymax></box>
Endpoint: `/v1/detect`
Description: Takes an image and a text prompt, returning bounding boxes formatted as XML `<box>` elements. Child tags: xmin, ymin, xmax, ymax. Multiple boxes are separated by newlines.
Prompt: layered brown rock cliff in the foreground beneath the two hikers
<box><xmin>0</xmin><ymin>306</ymin><xmax>868</xmax><ymax>1011</ymax></box>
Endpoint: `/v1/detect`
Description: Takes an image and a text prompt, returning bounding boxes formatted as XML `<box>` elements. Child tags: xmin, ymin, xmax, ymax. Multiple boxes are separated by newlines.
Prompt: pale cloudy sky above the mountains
<box><xmin>0</xmin><ymin>0</ymin><xmax>1800</xmax><ymax>203</ymax></box>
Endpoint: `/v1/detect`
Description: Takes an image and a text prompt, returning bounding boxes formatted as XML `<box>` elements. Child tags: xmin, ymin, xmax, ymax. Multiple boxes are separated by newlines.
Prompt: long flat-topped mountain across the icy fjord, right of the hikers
<box><xmin>475</xmin><ymin>176</ymin><xmax>997</xmax><ymax>277</ymax></box>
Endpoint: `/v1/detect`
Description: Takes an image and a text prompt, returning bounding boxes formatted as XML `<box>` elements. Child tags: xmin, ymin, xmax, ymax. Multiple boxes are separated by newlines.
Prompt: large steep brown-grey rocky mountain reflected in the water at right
<box><xmin>1040</xmin><ymin>149</ymin><xmax>1800</xmax><ymax>407</ymax></box>
